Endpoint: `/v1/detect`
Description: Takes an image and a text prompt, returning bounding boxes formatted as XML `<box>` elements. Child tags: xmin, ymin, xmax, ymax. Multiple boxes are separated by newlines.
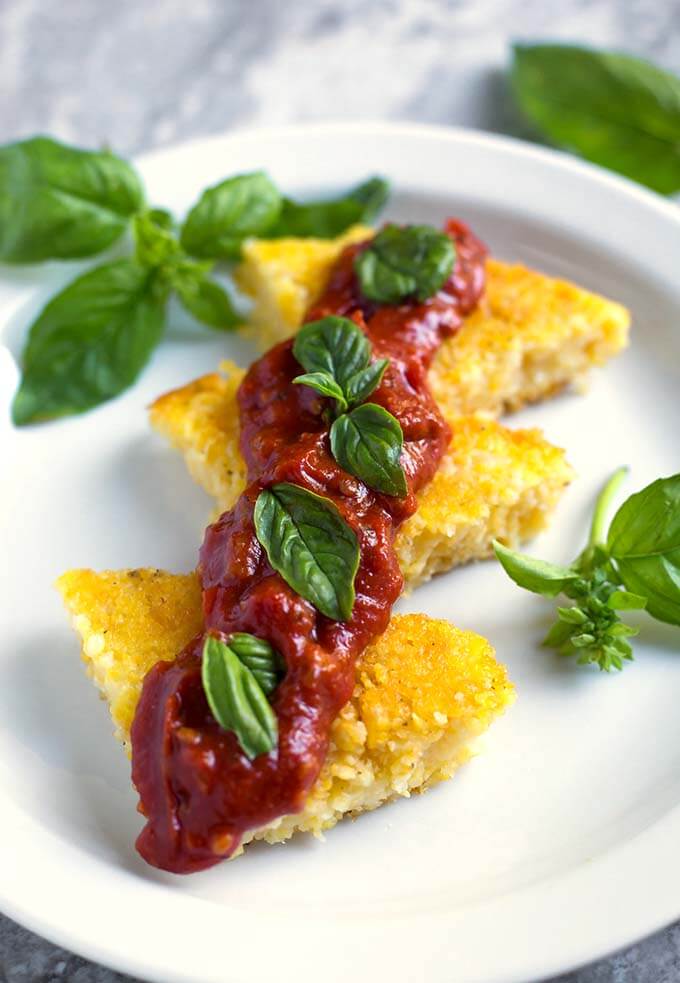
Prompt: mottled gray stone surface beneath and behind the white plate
<box><xmin>0</xmin><ymin>0</ymin><xmax>680</xmax><ymax>983</ymax></box>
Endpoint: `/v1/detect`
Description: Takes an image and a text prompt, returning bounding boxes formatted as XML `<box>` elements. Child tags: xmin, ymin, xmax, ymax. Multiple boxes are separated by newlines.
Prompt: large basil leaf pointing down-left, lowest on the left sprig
<box><xmin>12</xmin><ymin>259</ymin><xmax>166</xmax><ymax>425</ymax></box>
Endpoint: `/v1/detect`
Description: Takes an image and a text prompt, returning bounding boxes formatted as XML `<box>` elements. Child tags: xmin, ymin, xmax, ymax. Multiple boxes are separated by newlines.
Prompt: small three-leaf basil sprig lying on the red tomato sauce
<box><xmin>293</xmin><ymin>317</ymin><xmax>408</xmax><ymax>498</ymax></box>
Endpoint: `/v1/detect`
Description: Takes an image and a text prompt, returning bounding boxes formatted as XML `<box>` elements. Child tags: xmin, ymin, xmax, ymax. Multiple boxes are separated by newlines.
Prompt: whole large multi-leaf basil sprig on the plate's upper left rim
<box><xmin>0</xmin><ymin>137</ymin><xmax>388</xmax><ymax>425</ymax></box>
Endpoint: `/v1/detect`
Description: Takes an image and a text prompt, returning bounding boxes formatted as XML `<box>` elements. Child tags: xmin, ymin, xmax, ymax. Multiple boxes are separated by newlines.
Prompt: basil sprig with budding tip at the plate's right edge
<box><xmin>494</xmin><ymin>468</ymin><xmax>680</xmax><ymax>672</ymax></box>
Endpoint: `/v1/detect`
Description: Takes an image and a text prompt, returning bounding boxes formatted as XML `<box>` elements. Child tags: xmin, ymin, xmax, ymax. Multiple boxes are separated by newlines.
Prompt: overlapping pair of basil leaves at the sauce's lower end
<box><xmin>201</xmin><ymin>632</ymin><xmax>281</xmax><ymax>760</ymax></box>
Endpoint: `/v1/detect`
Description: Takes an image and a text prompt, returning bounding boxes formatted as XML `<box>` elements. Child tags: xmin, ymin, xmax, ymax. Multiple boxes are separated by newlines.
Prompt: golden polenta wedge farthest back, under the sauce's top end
<box><xmin>236</xmin><ymin>226</ymin><xmax>630</xmax><ymax>416</ymax></box>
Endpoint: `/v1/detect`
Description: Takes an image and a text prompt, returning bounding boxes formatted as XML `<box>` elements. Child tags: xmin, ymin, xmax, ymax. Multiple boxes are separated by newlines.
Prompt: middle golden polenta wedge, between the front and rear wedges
<box><xmin>151</xmin><ymin>363</ymin><xmax>572</xmax><ymax>588</ymax></box>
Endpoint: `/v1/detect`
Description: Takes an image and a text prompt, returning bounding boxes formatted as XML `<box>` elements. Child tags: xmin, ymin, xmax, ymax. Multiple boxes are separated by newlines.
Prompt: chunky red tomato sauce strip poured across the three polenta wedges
<box><xmin>131</xmin><ymin>220</ymin><xmax>486</xmax><ymax>873</ymax></box>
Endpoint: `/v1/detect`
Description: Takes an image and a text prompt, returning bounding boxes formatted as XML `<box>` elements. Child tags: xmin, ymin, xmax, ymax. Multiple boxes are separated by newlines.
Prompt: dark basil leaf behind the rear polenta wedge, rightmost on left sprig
<box><xmin>267</xmin><ymin>177</ymin><xmax>390</xmax><ymax>239</ymax></box>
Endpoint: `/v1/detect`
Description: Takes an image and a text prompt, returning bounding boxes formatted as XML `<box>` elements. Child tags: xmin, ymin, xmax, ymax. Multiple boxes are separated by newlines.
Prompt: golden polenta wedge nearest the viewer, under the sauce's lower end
<box><xmin>57</xmin><ymin>570</ymin><xmax>514</xmax><ymax>843</ymax></box>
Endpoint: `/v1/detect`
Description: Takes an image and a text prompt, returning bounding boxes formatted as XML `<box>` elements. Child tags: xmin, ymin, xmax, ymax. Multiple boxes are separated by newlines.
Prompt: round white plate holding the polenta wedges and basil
<box><xmin>0</xmin><ymin>125</ymin><xmax>680</xmax><ymax>983</ymax></box>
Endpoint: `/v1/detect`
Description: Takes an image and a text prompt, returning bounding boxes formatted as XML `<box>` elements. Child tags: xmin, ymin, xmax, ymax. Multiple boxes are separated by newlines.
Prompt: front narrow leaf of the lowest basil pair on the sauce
<box><xmin>201</xmin><ymin>635</ymin><xmax>278</xmax><ymax>760</ymax></box>
